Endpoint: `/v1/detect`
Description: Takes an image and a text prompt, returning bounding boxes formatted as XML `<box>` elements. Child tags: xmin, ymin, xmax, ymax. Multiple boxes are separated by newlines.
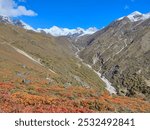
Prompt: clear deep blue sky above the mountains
<box><xmin>2</xmin><ymin>0</ymin><xmax>150</xmax><ymax>28</ymax></box>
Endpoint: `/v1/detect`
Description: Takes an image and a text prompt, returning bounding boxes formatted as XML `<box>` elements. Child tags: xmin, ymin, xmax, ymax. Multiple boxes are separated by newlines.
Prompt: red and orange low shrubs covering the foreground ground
<box><xmin>0</xmin><ymin>82</ymin><xmax>150</xmax><ymax>113</ymax></box>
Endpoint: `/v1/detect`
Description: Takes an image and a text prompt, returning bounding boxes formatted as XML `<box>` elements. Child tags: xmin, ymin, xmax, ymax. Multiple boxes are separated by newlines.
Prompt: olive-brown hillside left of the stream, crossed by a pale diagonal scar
<box><xmin>0</xmin><ymin>23</ymin><xmax>104</xmax><ymax>92</ymax></box>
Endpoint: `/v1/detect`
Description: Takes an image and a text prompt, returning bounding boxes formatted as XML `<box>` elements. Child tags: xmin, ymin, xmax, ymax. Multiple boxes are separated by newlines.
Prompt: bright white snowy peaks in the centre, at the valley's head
<box><xmin>37</xmin><ymin>26</ymin><xmax>98</xmax><ymax>36</ymax></box>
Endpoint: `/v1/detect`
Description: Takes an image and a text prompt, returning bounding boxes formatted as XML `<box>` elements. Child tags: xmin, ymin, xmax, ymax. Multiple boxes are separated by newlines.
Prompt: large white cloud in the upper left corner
<box><xmin>0</xmin><ymin>0</ymin><xmax>37</xmax><ymax>17</ymax></box>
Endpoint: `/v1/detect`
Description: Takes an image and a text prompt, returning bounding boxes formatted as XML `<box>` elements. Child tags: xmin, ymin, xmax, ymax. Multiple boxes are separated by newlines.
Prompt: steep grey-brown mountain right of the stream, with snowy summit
<box><xmin>76</xmin><ymin>12</ymin><xmax>150</xmax><ymax>98</ymax></box>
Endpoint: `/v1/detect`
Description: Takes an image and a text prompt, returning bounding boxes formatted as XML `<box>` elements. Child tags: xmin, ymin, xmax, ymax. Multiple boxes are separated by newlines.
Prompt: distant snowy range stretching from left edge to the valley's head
<box><xmin>0</xmin><ymin>16</ymin><xmax>98</xmax><ymax>37</ymax></box>
